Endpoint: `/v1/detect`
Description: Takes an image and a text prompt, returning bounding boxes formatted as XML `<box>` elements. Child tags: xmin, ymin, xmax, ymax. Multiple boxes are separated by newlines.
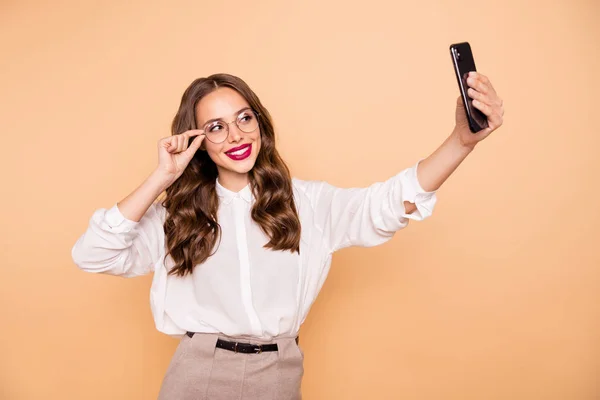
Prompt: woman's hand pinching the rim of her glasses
<box><xmin>157</xmin><ymin>129</ymin><xmax>205</xmax><ymax>183</ymax></box>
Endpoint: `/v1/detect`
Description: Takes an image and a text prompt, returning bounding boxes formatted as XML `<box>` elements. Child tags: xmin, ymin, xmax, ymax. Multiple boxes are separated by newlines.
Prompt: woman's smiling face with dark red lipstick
<box><xmin>196</xmin><ymin>87</ymin><xmax>260</xmax><ymax>182</ymax></box>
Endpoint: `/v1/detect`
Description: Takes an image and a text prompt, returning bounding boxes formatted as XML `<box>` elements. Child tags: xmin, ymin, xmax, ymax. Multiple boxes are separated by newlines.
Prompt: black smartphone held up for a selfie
<box><xmin>450</xmin><ymin>42</ymin><xmax>488</xmax><ymax>133</ymax></box>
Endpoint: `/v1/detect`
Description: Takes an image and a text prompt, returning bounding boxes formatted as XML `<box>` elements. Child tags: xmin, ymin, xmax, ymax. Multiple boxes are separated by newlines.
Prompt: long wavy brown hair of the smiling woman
<box><xmin>163</xmin><ymin>74</ymin><xmax>300</xmax><ymax>276</ymax></box>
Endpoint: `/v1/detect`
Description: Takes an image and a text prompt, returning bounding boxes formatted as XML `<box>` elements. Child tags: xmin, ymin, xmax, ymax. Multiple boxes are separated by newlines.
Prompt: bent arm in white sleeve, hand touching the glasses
<box><xmin>71</xmin><ymin>131</ymin><xmax>204</xmax><ymax>277</ymax></box>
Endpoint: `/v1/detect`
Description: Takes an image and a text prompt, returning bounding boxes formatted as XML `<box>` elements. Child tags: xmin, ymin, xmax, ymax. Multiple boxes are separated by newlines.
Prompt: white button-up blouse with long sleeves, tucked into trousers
<box><xmin>72</xmin><ymin>161</ymin><xmax>436</xmax><ymax>339</ymax></box>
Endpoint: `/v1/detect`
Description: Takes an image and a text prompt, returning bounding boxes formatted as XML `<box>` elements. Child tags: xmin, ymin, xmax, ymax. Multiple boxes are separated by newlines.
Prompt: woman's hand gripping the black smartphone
<box><xmin>454</xmin><ymin>71</ymin><xmax>504</xmax><ymax>147</ymax></box>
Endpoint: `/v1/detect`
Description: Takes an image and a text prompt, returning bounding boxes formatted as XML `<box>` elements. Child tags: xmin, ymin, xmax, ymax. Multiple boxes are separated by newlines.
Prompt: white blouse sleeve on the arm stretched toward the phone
<box><xmin>298</xmin><ymin>161</ymin><xmax>437</xmax><ymax>252</ymax></box>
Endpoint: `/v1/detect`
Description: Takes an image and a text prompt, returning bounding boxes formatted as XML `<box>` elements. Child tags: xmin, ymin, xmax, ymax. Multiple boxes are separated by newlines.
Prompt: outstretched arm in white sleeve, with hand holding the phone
<box><xmin>298</xmin><ymin>73</ymin><xmax>504</xmax><ymax>251</ymax></box>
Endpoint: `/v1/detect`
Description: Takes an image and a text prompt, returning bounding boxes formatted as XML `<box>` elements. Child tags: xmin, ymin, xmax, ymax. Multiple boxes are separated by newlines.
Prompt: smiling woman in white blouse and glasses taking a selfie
<box><xmin>72</xmin><ymin>73</ymin><xmax>503</xmax><ymax>400</ymax></box>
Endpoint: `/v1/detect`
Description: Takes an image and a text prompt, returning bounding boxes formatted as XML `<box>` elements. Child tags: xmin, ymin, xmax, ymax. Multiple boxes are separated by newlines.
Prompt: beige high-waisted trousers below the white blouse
<box><xmin>158</xmin><ymin>333</ymin><xmax>304</xmax><ymax>400</ymax></box>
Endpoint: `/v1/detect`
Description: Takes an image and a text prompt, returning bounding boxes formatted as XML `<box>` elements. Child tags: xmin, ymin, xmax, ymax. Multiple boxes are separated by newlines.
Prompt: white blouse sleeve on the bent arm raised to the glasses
<box><xmin>71</xmin><ymin>203</ymin><xmax>164</xmax><ymax>277</ymax></box>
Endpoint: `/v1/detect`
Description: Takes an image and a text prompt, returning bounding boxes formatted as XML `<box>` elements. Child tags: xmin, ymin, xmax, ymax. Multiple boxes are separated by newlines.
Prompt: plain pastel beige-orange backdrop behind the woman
<box><xmin>0</xmin><ymin>0</ymin><xmax>600</xmax><ymax>400</ymax></box>
